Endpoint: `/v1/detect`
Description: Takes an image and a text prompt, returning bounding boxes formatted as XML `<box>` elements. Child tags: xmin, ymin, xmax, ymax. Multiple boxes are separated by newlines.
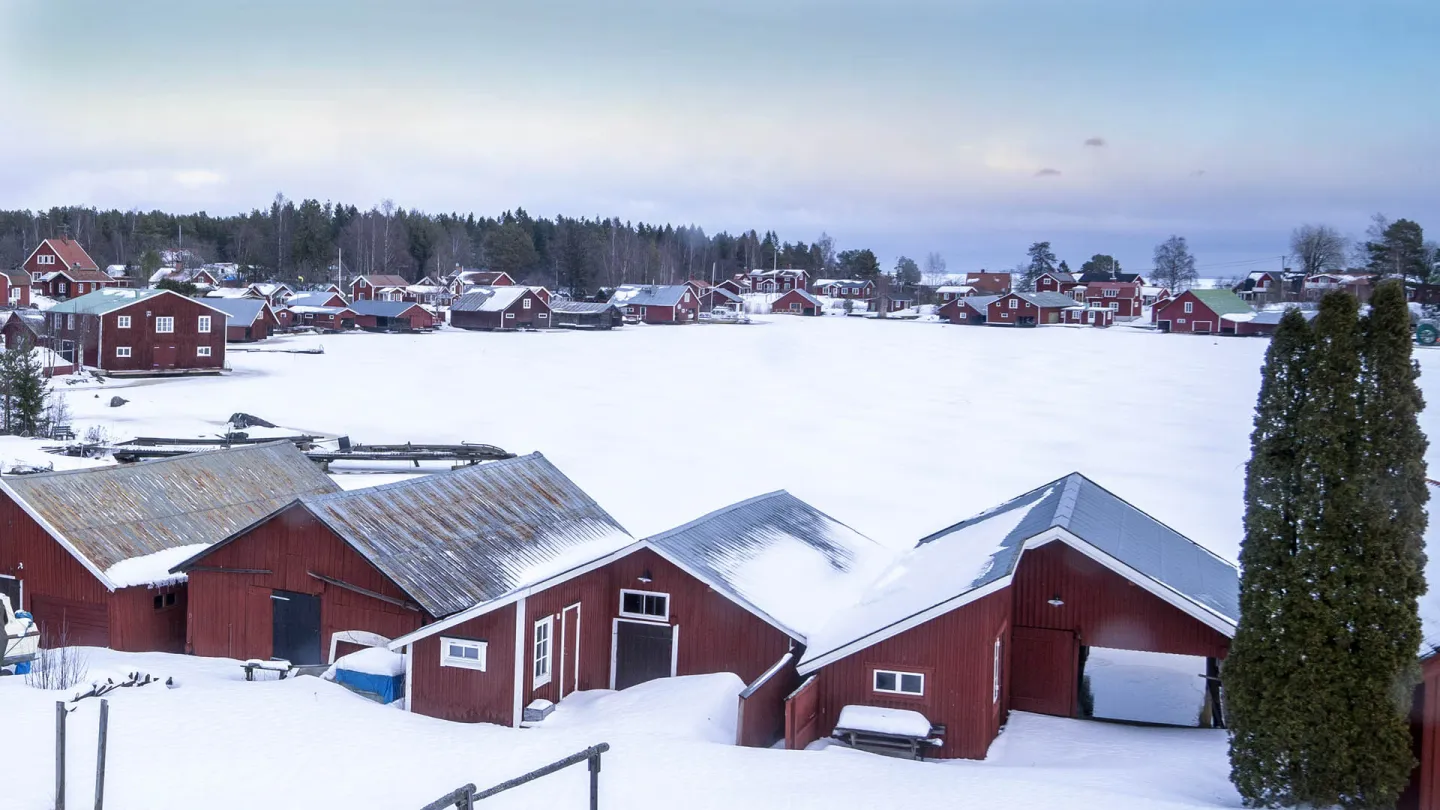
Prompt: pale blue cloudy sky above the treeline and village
<box><xmin>0</xmin><ymin>0</ymin><xmax>1440</xmax><ymax>275</ymax></box>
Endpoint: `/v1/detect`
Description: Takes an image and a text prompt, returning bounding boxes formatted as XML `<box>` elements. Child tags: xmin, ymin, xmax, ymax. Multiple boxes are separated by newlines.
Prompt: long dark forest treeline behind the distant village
<box><xmin>0</xmin><ymin>195</ymin><xmax>880</xmax><ymax>293</ymax></box>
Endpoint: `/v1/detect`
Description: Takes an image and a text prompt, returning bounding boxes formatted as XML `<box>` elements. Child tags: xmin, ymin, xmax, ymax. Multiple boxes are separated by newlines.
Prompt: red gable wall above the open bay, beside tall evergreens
<box><xmin>1011</xmin><ymin>542</ymin><xmax>1230</xmax><ymax>659</ymax></box>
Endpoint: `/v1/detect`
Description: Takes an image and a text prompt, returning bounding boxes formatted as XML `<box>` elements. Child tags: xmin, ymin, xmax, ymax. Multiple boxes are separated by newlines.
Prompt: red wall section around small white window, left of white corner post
<box><xmin>409</xmin><ymin>605</ymin><xmax>516</xmax><ymax>725</ymax></box>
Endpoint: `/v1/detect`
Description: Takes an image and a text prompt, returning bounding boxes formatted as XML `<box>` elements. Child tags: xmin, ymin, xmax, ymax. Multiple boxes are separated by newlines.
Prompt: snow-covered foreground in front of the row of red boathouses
<box><xmin>0</xmin><ymin>649</ymin><xmax>1240</xmax><ymax>810</ymax></box>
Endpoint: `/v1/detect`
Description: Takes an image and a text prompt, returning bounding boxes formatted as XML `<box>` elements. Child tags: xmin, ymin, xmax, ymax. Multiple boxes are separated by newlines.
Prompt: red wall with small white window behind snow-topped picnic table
<box><xmin>816</xmin><ymin>589</ymin><xmax>1011</xmax><ymax>760</ymax></box>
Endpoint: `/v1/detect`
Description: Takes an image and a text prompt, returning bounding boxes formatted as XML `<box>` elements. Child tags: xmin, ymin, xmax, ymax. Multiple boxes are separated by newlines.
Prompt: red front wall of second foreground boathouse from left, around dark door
<box><xmin>186</xmin><ymin>506</ymin><xmax>426</xmax><ymax>659</ymax></box>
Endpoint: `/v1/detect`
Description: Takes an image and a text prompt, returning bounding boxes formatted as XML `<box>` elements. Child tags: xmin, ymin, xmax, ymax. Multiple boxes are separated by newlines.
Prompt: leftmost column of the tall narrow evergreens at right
<box><xmin>1224</xmin><ymin>310</ymin><xmax>1312</xmax><ymax>806</ymax></box>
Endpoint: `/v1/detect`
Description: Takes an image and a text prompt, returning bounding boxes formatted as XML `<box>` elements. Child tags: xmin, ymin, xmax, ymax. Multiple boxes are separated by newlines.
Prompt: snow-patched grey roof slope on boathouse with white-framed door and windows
<box><xmin>645</xmin><ymin>490</ymin><xmax>893</xmax><ymax>640</ymax></box>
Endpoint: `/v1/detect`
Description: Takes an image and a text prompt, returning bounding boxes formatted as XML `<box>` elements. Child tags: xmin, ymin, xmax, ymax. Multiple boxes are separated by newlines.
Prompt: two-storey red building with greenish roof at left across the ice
<box><xmin>45</xmin><ymin>288</ymin><xmax>226</xmax><ymax>375</ymax></box>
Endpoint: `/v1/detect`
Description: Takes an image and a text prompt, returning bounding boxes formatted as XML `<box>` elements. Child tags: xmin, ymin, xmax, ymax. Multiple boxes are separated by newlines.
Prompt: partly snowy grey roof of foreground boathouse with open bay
<box><xmin>799</xmin><ymin>473</ymin><xmax>1240</xmax><ymax>673</ymax></box>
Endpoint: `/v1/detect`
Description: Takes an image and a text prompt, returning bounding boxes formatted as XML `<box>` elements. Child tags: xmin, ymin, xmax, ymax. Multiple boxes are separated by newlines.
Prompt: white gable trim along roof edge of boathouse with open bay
<box><xmin>796</xmin><ymin>526</ymin><xmax>1236</xmax><ymax>675</ymax></box>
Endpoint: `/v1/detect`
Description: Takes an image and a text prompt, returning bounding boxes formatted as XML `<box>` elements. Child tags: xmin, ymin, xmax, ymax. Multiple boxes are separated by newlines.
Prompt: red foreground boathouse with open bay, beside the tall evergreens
<box><xmin>786</xmin><ymin>474</ymin><xmax>1240</xmax><ymax>760</ymax></box>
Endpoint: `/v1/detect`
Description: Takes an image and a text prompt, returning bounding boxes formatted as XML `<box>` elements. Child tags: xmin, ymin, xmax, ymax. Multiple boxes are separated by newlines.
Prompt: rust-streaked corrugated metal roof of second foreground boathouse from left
<box><xmin>301</xmin><ymin>453</ymin><xmax>635</xmax><ymax>617</ymax></box>
